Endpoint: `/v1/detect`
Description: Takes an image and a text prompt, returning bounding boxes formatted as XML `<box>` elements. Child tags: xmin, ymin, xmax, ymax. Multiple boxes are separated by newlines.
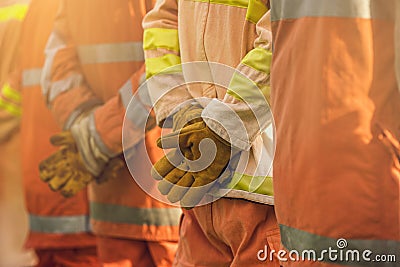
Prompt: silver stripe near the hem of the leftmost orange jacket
<box><xmin>29</xmin><ymin>214</ymin><xmax>90</xmax><ymax>234</ymax></box>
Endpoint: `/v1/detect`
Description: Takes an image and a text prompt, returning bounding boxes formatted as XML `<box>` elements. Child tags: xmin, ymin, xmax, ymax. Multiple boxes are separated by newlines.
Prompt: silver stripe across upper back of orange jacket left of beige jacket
<box><xmin>77</xmin><ymin>42</ymin><xmax>144</xmax><ymax>64</ymax></box>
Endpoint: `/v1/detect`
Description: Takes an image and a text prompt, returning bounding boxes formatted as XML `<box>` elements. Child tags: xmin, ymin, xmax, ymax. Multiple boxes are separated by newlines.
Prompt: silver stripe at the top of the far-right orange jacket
<box><xmin>271</xmin><ymin>0</ymin><xmax>378</xmax><ymax>21</ymax></box>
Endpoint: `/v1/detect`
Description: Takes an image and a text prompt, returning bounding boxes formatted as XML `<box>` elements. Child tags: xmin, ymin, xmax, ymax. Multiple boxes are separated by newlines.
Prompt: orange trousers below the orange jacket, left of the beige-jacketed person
<box><xmin>97</xmin><ymin>237</ymin><xmax>178</xmax><ymax>267</ymax></box>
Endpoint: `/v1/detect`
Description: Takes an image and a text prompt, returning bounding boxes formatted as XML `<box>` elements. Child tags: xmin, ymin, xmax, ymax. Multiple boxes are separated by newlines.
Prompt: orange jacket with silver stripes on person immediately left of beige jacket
<box><xmin>42</xmin><ymin>0</ymin><xmax>181</xmax><ymax>240</ymax></box>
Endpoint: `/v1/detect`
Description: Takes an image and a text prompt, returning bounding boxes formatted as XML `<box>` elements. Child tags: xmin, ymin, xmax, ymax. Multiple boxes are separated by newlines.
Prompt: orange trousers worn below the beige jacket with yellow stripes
<box><xmin>174</xmin><ymin>198</ymin><xmax>280</xmax><ymax>267</ymax></box>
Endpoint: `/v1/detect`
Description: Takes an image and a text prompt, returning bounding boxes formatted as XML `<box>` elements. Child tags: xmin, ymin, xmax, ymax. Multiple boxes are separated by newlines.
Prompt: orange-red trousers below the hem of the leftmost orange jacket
<box><xmin>36</xmin><ymin>247</ymin><xmax>99</xmax><ymax>267</ymax></box>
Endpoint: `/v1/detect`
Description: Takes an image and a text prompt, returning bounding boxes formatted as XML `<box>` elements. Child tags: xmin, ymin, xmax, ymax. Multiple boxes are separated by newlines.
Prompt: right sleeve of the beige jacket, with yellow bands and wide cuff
<box><xmin>202</xmin><ymin>1</ymin><xmax>272</xmax><ymax>150</ymax></box>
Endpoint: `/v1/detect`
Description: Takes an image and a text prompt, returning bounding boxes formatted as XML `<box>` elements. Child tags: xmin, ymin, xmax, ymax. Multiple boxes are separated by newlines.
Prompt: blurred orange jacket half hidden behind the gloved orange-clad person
<box><xmin>1</xmin><ymin>0</ymin><xmax>96</xmax><ymax>249</ymax></box>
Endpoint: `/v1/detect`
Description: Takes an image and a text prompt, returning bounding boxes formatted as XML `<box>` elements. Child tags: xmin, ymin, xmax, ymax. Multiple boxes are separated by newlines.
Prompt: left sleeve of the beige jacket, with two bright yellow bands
<box><xmin>143</xmin><ymin>0</ymin><xmax>192</xmax><ymax>125</ymax></box>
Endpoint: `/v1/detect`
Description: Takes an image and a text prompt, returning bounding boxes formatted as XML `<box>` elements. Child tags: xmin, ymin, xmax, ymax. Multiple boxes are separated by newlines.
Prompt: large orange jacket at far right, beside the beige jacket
<box><xmin>271</xmin><ymin>0</ymin><xmax>400</xmax><ymax>266</ymax></box>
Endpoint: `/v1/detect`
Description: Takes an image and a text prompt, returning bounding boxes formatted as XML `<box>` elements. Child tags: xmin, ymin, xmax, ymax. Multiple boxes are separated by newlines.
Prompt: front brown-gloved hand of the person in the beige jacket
<box><xmin>152</xmin><ymin>120</ymin><xmax>238</xmax><ymax>207</ymax></box>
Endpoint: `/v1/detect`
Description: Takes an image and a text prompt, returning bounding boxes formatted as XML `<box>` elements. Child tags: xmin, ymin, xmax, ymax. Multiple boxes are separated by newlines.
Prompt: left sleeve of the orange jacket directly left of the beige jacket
<box><xmin>41</xmin><ymin>0</ymin><xmax>101</xmax><ymax>130</ymax></box>
